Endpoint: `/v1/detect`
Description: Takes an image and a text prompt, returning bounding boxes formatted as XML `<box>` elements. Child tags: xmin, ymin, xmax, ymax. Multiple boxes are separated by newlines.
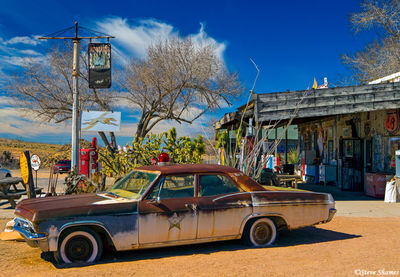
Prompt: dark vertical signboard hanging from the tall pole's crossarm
<box><xmin>88</xmin><ymin>43</ymin><xmax>111</xmax><ymax>88</ymax></box>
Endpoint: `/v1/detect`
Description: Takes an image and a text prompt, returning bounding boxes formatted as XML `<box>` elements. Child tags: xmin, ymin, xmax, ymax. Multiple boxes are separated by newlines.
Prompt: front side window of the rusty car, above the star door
<box><xmin>149</xmin><ymin>175</ymin><xmax>194</xmax><ymax>199</ymax></box>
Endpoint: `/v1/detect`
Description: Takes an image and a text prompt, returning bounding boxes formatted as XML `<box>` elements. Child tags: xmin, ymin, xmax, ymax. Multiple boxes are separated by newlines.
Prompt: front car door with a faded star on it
<box><xmin>139</xmin><ymin>175</ymin><xmax>197</xmax><ymax>245</ymax></box>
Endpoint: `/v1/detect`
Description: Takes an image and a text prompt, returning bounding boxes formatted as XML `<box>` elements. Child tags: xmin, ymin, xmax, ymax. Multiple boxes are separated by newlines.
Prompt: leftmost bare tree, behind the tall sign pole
<box><xmin>7</xmin><ymin>45</ymin><xmax>115</xmax><ymax>154</ymax></box>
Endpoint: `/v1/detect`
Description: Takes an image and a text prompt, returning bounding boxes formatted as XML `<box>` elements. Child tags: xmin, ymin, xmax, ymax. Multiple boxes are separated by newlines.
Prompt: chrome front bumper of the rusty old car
<box><xmin>13</xmin><ymin>218</ymin><xmax>49</xmax><ymax>251</ymax></box>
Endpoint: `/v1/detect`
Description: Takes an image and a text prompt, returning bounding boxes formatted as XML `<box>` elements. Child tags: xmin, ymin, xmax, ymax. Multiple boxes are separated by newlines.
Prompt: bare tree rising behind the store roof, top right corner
<box><xmin>342</xmin><ymin>0</ymin><xmax>400</xmax><ymax>83</ymax></box>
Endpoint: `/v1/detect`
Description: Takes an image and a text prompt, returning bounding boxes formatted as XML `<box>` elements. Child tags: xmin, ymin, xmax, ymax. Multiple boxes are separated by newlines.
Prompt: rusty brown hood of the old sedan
<box><xmin>15</xmin><ymin>193</ymin><xmax>137</xmax><ymax>222</ymax></box>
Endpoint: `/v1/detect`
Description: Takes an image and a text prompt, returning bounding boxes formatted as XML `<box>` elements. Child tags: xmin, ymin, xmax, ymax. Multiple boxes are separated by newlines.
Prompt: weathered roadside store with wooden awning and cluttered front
<box><xmin>217</xmin><ymin>83</ymin><xmax>400</xmax><ymax>197</ymax></box>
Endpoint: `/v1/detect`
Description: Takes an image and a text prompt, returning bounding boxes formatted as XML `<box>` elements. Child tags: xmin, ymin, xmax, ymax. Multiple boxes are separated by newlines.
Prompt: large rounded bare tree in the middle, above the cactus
<box><xmin>118</xmin><ymin>39</ymin><xmax>241</xmax><ymax>137</ymax></box>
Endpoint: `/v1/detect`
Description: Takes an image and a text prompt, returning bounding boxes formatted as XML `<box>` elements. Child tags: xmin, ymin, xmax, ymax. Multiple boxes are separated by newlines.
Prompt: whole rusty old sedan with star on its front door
<box><xmin>14</xmin><ymin>164</ymin><xmax>336</xmax><ymax>263</ymax></box>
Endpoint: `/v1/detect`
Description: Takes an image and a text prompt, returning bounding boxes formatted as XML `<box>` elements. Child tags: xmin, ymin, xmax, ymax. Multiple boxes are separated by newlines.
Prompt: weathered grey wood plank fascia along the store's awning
<box><xmin>255</xmin><ymin>83</ymin><xmax>400</xmax><ymax>122</ymax></box>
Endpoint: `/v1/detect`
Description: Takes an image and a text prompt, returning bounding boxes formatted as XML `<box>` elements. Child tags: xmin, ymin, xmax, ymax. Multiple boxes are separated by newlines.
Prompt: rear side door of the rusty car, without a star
<box><xmin>197</xmin><ymin>174</ymin><xmax>252</xmax><ymax>239</ymax></box>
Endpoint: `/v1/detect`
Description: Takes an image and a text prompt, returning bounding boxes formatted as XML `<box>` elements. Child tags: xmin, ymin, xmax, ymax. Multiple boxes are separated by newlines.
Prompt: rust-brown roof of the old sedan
<box><xmin>136</xmin><ymin>164</ymin><xmax>240</xmax><ymax>174</ymax></box>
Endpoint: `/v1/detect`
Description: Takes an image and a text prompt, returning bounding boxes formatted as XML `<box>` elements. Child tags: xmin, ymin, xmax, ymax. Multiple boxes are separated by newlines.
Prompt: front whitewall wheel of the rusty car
<box><xmin>56</xmin><ymin>227</ymin><xmax>103</xmax><ymax>264</ymax></box>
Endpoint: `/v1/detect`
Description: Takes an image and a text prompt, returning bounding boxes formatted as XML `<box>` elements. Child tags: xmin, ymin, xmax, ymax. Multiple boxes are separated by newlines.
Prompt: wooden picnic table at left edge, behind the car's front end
<box><xmin>0</xmin><ymin>177</ymin><xmax>42</xmax><ymax>208</ymax></box>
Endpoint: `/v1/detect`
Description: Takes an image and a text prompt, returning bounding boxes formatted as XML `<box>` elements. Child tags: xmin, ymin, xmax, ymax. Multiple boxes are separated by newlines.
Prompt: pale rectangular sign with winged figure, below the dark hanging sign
<box><xmin>81</xmin><ymin>111</ymin><xmax>121</xmax><ymax>132</ymax></box>
